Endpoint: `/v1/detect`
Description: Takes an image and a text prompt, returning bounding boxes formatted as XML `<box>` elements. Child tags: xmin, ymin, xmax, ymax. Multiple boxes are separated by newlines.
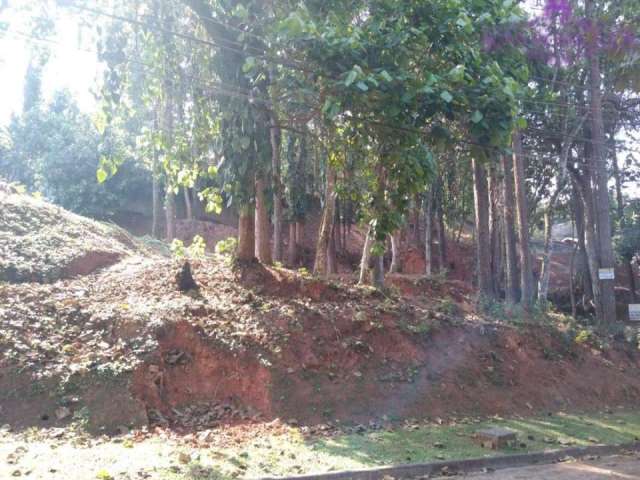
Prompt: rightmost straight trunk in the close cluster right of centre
<box><xmin>512</xmin><ymin>130</ymin><xmax>533</xmax><ymax>308</ymax></box>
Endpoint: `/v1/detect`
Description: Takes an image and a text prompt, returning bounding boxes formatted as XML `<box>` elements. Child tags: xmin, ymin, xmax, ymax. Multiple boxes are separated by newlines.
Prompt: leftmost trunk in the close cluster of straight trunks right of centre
<box><xmin>472</xmin><ymin>158</ymin><xmax>494</xmax><ymax>298</ymax></box>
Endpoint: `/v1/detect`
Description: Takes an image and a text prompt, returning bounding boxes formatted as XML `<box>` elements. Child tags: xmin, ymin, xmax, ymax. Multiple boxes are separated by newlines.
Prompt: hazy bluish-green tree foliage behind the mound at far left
<box><xmin>0</xmin><ymin>87</ymin><xmax>150</xmax><ymax>219</ymax></box>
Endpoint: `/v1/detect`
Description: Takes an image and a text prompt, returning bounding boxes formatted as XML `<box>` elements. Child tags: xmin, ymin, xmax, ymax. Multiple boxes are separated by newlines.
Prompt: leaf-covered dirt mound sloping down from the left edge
<box><xmin>0</xmin><ymin>184</ymin><xmax>136</xmax><ymax>283</ymax></box>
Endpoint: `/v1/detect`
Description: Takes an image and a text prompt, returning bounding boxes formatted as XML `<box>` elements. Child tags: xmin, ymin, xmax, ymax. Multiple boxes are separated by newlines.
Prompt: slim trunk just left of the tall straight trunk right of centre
<box><xmin>500</xmin><ymin>155</ymin><xmax>518</xmax><ymax>304</ymax></box>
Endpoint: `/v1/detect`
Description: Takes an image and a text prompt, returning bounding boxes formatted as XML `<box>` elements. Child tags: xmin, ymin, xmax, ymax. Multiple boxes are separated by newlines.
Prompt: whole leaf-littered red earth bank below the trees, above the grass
<box><xmin>0</xmin><ymin>187</ymin><xmax>640</xmax><ymax>432</ymax></box>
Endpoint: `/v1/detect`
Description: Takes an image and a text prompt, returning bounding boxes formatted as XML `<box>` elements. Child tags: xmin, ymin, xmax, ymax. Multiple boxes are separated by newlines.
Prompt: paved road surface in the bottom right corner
<box><xmin>453</xmin><ymin>454</ymin><xmax>640</xmax><ymax>480</ymax></box>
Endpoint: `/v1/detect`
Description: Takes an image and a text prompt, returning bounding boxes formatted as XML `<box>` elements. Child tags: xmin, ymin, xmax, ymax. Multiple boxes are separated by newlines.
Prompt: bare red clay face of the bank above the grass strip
<box><xmin>133</xmin><ymin>262</ymin><xmax>640</xmax><ymax>424</ymax></box>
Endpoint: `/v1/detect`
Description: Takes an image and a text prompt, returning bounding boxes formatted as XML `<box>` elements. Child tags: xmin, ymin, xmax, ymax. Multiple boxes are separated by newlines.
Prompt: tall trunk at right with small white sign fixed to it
<box><xmin>585</xmin><ymin>0</ymin><xmax>616</xmax><ymax>323</ymax></box>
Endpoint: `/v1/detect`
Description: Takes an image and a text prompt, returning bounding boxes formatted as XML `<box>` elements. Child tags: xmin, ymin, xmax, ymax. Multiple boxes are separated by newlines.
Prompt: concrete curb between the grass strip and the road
<box><xmin>260</xmin><ymin>442</ymin><xmax>640</xmax><ymax>480</ymax></box>
